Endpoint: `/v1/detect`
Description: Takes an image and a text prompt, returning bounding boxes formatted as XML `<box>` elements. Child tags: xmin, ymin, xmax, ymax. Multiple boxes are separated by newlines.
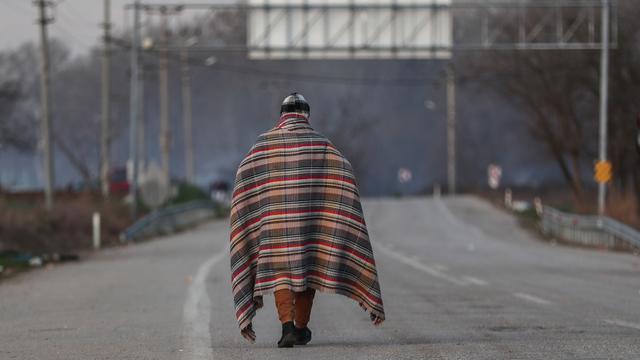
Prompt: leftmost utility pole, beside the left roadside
<box><xmin>36</xmin><ymin>0</ymin><xmax>55</xmax><ymax>211</ymax></box>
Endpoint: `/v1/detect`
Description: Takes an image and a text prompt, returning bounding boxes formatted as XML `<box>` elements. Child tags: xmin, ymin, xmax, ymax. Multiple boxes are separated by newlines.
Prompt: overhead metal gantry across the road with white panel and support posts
<box><xmin>125</xmin><ymin>0</ymin><xmax>618</xmax><ymax>214</ymax></box>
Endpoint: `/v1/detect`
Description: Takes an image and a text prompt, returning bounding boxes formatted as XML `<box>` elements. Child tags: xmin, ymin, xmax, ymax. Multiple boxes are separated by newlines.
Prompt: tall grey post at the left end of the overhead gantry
<box><xmin>129</xmin><ymin>0</ymin><xmax>141</xmax><ymax>219</ymax></box>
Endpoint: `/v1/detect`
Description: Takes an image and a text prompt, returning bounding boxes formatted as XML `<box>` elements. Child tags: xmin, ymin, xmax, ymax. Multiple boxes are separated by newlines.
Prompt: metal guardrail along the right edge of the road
<box><xmin>540</xmin><ymin>206</ymin><xmax>640</xmax><ymax>249</ymax></box>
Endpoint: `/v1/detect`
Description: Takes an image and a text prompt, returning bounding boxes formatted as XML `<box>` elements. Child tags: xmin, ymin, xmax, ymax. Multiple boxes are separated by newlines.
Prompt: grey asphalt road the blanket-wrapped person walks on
<box><xmin>0</xmin><ymin>197</ymin><xmax>640</xmax><ymax>360</ymax></box>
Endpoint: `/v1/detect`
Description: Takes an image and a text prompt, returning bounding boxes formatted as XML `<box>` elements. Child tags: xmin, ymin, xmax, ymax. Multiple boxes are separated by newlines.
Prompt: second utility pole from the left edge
<box><xmin>100</xmin><ymin>0</ymin><xmax>111</xmax><ymax>197</ymax></box>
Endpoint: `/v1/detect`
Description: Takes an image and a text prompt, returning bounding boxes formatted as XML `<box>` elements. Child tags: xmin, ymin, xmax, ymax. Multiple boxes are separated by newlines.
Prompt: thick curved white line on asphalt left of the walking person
<box><xmin>181</xmin><ymin>247</ymin><xmax>229</xmax><ymax>360</ymax></box>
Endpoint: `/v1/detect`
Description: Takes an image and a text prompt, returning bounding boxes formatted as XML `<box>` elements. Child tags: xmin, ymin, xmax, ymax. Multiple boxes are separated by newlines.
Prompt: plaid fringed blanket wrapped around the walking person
<box><xmin>230</xmin><ymin>113</ymin><xmax>384</xmax><ymax>341</ymax></box>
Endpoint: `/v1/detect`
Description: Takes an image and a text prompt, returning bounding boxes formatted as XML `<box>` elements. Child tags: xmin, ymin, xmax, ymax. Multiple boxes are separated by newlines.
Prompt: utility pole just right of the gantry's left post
<box><xmin>158</xmin><ymin>6</ymin><xmax>171</xmax><ymax>184</ymax></box>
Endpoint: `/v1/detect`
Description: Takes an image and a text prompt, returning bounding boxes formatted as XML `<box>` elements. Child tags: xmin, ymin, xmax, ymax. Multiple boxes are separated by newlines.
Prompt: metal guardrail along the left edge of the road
<box><xmin>120</xmin><ymin>200</ymin><xmax>215</xmax><ymax>242</ymax></box>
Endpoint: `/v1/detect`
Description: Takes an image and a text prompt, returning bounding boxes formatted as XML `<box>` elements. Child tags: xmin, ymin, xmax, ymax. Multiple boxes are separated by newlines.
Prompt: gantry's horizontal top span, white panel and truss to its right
<box><xmin>248</xmin><ymin>0</ymin><xmax>617</xmax><ymax>58</ymax></box>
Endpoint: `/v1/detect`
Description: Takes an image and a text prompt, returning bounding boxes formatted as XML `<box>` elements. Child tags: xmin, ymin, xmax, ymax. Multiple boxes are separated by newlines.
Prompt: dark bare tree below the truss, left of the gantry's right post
<box><xmin>459</xmin><ymin>51</ymin><xmax>597</xmax><ymax>202</ymax></box>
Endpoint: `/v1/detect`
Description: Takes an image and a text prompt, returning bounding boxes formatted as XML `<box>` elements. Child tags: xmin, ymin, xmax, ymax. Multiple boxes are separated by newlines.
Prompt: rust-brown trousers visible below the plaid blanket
<box><xmin>273</xmin><ymin>288</ymin><xmax>316</xmax><ymax>329</ymax></box>
